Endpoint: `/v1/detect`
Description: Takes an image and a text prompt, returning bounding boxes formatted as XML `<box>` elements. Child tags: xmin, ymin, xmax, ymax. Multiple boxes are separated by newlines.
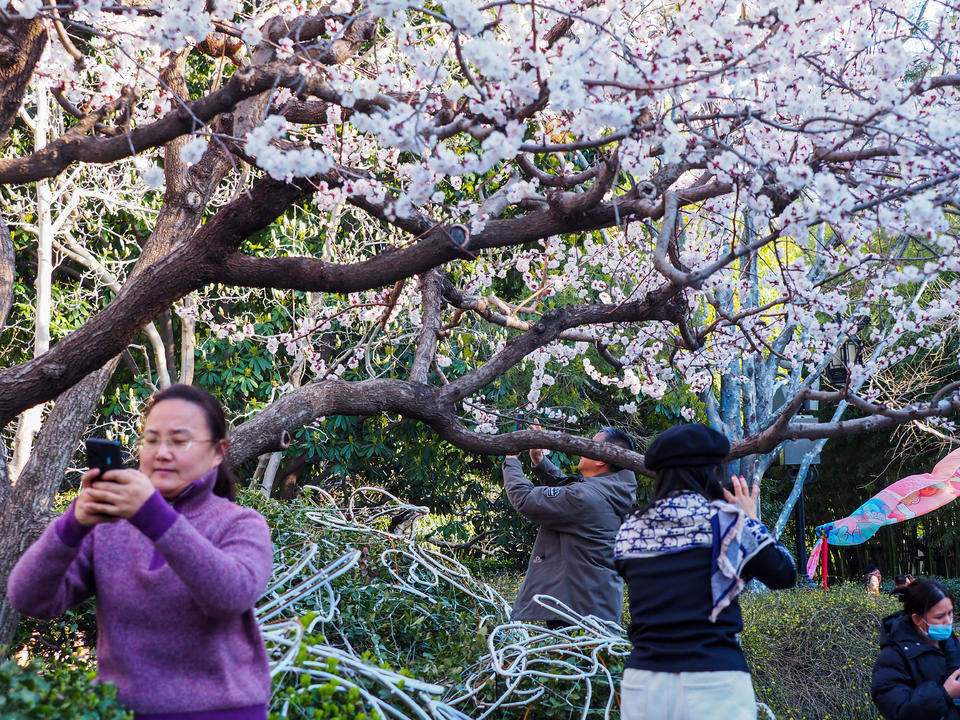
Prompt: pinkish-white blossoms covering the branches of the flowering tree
<box><xmin>7</xmin><ymin>0</ymin><xmax>960</xmax><ymax>438</ymax></box>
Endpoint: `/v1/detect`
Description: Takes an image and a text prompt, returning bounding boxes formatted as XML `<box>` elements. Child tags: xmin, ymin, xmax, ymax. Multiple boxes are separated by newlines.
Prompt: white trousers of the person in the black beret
<box><xmin>620</xmin><ymin>668</ymin><xmax>757</xmax><ymax>720</ymax></box>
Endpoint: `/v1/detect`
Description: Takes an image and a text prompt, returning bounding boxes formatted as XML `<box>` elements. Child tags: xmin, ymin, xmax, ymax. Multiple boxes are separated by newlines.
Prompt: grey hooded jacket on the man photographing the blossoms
<box><xmin>503</xmin><ymin>458</ymin><xmax>637</xmax><ymax>623</ymax></box>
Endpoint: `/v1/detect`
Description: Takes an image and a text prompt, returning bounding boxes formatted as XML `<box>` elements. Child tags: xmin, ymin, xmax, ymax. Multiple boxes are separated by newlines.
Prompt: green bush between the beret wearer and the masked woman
<box><xmin>740</xmin><ymin>583</ymin><xmax>901</xmax><ymax>720</ymax></box>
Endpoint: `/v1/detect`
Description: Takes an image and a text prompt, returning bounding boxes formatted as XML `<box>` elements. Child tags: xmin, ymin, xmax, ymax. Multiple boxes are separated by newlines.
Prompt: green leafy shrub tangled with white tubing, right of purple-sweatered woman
<box><xmin>238</xmin><ymin>489</ymin><xmax>490</xmax><ymax>718</ymax></box>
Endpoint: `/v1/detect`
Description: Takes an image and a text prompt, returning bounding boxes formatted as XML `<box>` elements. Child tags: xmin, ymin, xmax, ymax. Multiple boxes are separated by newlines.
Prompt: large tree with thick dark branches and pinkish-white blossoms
<box><xmin>0</xmin><ymin>0</ymin><xmax>960</xmax><ymax>642</ymax></box>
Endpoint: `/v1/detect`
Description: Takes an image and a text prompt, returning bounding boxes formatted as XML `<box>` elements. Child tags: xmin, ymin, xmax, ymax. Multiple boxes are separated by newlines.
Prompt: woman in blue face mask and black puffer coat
<box><xmin>871</xmin><ymin>578</ymin><xmax>960</xmax><ymax>720</ymax></box>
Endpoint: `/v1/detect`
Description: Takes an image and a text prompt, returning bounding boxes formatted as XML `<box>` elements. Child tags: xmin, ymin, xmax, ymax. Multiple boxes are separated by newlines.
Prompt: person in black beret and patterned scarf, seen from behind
<box><xmin>614</xmin><ymin>424</ymin><xmax>797</xmax><ymax>720</ymax></box>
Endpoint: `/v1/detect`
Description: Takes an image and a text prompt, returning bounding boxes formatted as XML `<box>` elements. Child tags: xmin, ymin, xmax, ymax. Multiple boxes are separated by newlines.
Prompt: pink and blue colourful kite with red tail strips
<box><xmin>807</xmin><ymin>450</ymin><xmax>960</xmax><ymax>587</ymax></box>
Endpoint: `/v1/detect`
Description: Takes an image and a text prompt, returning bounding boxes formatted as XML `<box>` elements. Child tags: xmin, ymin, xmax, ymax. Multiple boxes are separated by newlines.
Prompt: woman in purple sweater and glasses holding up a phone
<box><xmin>7</xmin><ymin>385</ymin><xmax>273</xmax><ymax>720</ymax></box>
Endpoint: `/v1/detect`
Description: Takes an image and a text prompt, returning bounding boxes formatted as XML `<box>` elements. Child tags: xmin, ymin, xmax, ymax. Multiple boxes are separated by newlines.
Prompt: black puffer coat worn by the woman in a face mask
<box><xmin>870</xmin><ymin>613</ymin><xmax>960</xmax><ymax>720</ymax></box>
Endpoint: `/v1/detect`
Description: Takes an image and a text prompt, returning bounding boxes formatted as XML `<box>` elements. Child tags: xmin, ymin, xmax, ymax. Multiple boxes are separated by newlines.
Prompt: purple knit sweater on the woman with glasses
<box><xmin>7</xmin><ymin>469</ymin><xmax>273</xmax><ymax>720</ymax></box>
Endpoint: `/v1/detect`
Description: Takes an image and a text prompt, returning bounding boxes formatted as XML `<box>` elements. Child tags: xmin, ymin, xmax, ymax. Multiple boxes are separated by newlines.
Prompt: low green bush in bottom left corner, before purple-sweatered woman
<box><xmin>0</xmin><ymin>660</ymin><xmax>133</xmax><ymax>720</ymax></box>
